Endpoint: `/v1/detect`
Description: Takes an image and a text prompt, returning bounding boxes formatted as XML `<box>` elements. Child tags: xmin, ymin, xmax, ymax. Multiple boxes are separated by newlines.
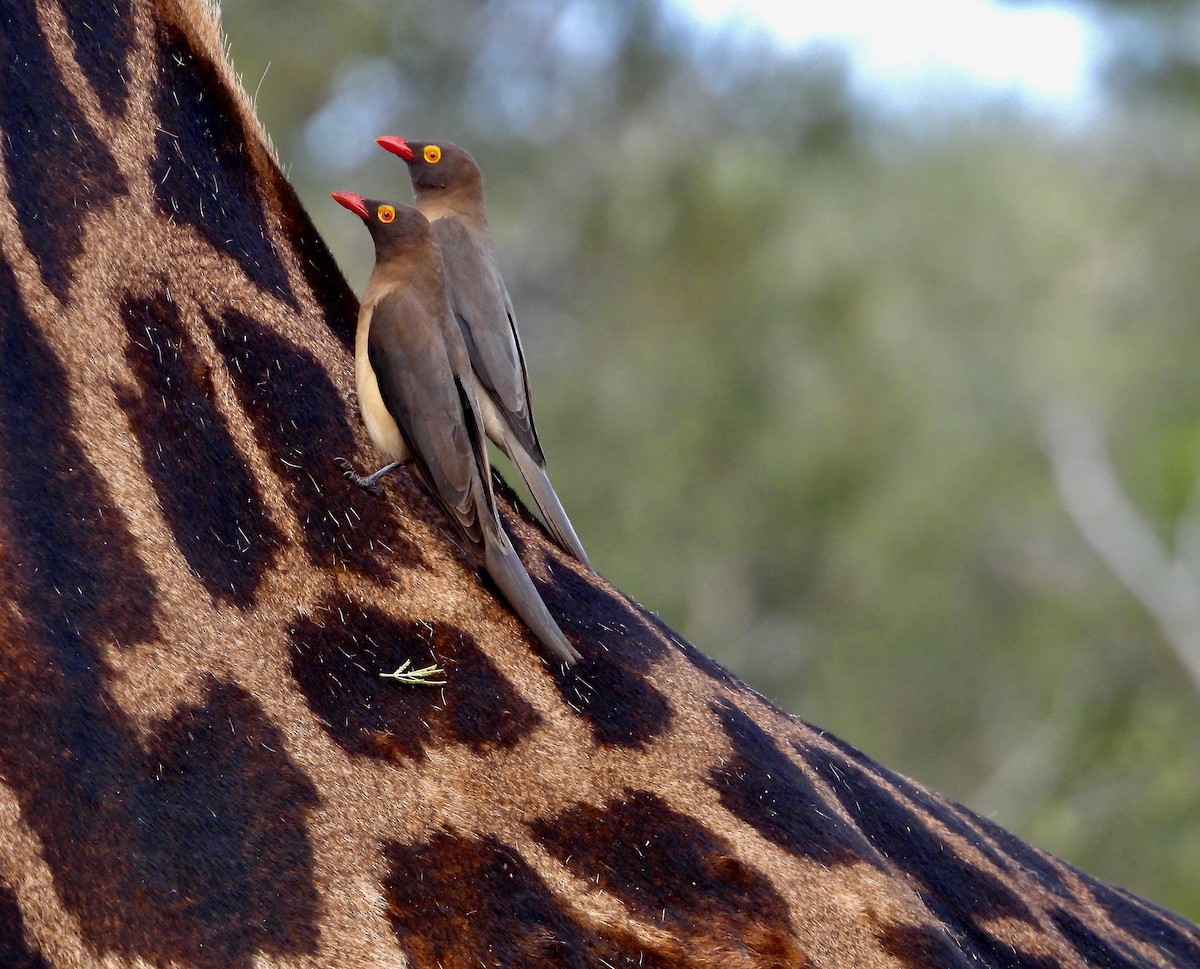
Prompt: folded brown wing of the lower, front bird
<box><xmin>367</xmin><ymin>289</ymin><xmax>496</xmax><ymax>558</ymax></box>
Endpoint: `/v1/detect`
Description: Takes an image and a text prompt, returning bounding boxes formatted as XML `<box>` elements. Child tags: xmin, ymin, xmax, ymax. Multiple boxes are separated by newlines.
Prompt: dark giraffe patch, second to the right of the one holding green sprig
<box><xmin>708</xmin><ymin>702</ymin><xmax>881</xmax><ymax>867</ymax></box>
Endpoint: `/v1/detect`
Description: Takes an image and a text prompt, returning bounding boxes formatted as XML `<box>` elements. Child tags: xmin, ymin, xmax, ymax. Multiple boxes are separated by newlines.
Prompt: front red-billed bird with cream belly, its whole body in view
<box><xmin>332</xmin><ymin>192</ymin><xmax>580</xmax><ymax>666</ymax></box>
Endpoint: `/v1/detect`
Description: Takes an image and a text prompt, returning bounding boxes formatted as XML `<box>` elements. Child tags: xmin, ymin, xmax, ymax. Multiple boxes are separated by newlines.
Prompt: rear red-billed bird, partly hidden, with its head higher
<box><xmin>376</xmin><ymin>134</ymin><xmax>594</xmax><ymax>571</ymax></box>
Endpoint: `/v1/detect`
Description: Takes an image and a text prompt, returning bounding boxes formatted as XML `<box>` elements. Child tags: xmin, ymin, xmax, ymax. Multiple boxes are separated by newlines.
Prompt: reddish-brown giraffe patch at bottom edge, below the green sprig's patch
<box><xmin>383</xmin><ymin>830</ymin><xmax>787</xmax><ymax>969</ymax></box>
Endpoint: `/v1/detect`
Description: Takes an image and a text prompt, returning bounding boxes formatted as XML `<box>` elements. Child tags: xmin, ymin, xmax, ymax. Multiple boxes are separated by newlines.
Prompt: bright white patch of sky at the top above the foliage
<box><xmin>676</xmin><ymin>0</ymin><xmax>1100</xmax><ymax>113</ymax></box>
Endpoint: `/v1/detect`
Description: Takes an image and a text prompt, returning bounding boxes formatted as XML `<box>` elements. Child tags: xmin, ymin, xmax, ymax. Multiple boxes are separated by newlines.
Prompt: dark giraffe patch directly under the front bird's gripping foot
<box><xmin>204</xmin><ymin>309</ymin><xmax>427</xmax><ymax>570</ymax></box>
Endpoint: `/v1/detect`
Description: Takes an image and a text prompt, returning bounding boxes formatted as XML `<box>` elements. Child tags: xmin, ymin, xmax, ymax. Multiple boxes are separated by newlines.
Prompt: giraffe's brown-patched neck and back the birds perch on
<box><xmin>0</xmin><ymin>0</ymin><xmax>1200</xmax><ymax>969</ymax></box>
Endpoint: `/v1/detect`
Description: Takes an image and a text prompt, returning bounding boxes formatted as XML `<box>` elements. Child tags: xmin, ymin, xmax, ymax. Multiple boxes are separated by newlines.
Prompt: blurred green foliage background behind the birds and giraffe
<box><xmin>223</xmin><ymin>0</ymin><xmax>1200</xmax><ymax>919</ymax></box>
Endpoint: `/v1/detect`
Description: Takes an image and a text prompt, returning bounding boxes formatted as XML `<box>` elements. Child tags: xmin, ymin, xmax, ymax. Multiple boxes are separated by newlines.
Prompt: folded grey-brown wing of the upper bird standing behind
<box><xmin>432</xmin><ymin>216</ymin><xmax>546</xmax><ymax>465</ymax></box>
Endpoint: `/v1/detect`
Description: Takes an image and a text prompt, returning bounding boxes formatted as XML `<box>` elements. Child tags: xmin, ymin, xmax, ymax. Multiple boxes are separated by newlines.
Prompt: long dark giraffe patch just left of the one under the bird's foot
<box><xmin>116</xmin><ymin>293</ymin><xmax>283</xmax><ymax>608</ymax></box>
